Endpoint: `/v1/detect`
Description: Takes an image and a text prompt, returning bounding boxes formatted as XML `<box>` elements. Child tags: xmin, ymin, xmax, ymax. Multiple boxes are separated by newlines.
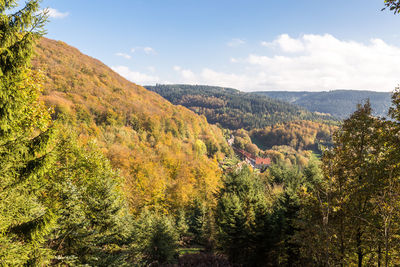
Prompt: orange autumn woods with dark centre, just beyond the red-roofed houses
<box><xmin>227</xmin><ymin>121</ymin><xmax>338</xmax><ymax>168</ymax></box>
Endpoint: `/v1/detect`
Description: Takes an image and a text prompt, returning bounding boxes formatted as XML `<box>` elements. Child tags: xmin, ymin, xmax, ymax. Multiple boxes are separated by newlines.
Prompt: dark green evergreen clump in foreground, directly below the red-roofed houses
<box><xmin>215</xmin><ymin>167</ymin><xmax>279</xmax><ymax>266</ymax></box>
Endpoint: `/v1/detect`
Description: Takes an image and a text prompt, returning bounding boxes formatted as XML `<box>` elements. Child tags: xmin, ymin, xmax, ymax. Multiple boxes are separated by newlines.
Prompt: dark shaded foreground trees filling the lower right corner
<box><xmin>215</xmin><ymin>96</ymin><xmax>400</xmax><ymax>266</ymax></box>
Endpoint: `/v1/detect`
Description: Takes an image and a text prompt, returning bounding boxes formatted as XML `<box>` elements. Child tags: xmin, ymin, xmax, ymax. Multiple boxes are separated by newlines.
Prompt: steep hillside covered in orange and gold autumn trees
<box><xmin>33</xmin><ymin>38</ymin><xmax>231</xmax><ymax>212</ymax></box>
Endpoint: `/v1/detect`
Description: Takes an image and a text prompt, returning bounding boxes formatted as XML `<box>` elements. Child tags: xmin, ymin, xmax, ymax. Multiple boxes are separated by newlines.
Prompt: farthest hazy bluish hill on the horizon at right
<box><xmin>253</xmin><ymin>90</ymin><xmax>391</xmax><ymax>119</ymax></box>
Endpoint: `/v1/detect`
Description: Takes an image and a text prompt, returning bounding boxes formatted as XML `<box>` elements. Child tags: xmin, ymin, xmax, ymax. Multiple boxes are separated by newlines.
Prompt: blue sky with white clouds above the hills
<box><xmin>42</xmin><ymin>0</ymin><xmax>400</xmax><ymax>91</ymax></box>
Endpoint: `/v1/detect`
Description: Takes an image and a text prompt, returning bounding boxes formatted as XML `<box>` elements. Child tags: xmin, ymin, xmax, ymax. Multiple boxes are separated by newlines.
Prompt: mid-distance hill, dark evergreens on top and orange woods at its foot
<box><xmin>147</xmin><ymin>85</ymin><xmax>338</xmax><ymax>166</ymax></box>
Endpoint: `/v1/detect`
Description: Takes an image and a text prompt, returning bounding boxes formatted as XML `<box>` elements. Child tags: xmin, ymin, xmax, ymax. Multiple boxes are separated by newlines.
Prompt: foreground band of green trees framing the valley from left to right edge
<box><xmin>0</xmin><ymin>0</ymin><xmax>400</xmax><ymax>266</ymax></box>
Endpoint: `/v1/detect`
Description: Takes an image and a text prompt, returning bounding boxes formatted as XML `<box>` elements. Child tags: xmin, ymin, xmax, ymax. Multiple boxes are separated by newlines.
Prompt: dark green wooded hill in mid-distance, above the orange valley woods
<box><xmin>146</xmin><ymin>84</ymin><xmax>332</xmax><ymax>130</ymax></box>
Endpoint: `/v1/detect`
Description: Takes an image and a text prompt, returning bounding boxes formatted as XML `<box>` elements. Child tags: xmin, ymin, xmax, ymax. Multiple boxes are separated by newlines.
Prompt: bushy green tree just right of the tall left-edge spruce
<box><xmin>47</xmin><ymin>127</ymin><xmax>132</xmax><ymax>266</ymax></box>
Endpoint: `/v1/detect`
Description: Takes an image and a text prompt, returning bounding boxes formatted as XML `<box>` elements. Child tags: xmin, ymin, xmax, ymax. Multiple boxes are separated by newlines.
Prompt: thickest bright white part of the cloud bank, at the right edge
<box><xmin>247</xmin><ymin>34</ymin><xmax>400</xmax><ymax>91</ymax></box>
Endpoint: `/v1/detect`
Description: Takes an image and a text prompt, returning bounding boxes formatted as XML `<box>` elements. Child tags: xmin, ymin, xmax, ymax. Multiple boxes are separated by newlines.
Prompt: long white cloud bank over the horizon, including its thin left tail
<box><xmin>171</xmin><ymin>34</ymin><xmax>400</xmax><ymax>91</ymax></box>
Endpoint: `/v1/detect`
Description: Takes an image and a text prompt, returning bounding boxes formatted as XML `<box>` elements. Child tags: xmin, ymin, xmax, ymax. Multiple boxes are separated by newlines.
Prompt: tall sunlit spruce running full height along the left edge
<box><xmin>0</xmin><ymin>0</ymin><xmax>56</xmax><ymax>266</ymax></box>
